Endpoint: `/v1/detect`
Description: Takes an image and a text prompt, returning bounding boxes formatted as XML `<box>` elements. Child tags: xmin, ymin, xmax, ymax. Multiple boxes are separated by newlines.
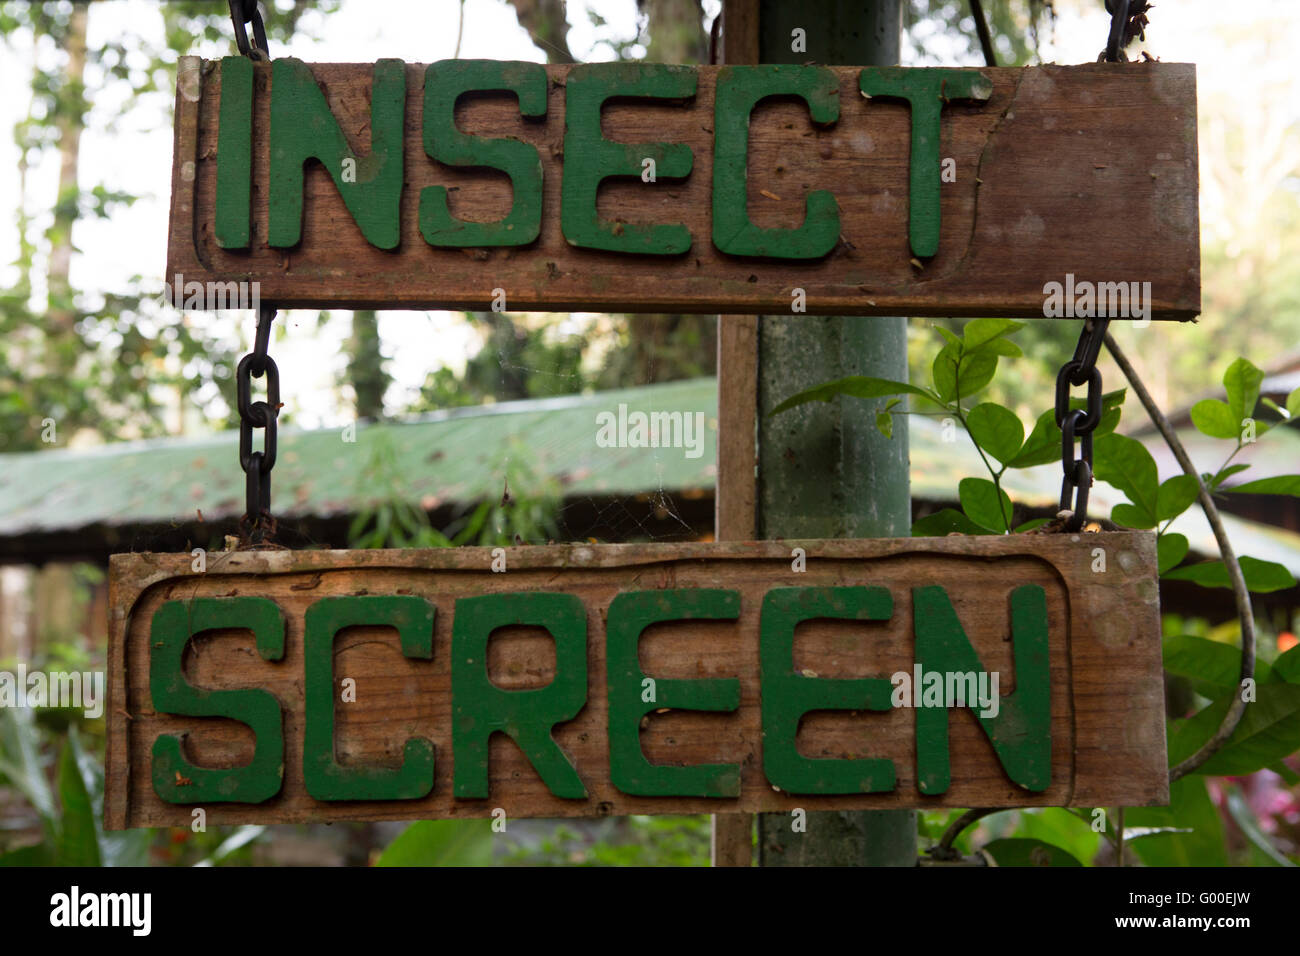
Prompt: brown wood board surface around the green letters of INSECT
<box><xmin>168</xmin><ymin>57</ymin><xmax>1200</xmax><ymax>320</ymax></box>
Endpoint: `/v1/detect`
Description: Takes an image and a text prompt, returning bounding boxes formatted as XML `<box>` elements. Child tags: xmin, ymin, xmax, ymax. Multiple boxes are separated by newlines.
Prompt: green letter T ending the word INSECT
<box><xmin>858</xmin><ymin>66</ymin><xmax>993</xmax><ymax>258</ymax></box>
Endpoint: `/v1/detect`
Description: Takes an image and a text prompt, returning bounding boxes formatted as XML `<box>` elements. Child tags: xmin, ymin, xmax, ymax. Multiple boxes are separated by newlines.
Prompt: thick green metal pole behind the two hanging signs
<box><xmin>758</xmin><ymin>0</ymin><xmax>917</xmax><ymax>866</ymax></box>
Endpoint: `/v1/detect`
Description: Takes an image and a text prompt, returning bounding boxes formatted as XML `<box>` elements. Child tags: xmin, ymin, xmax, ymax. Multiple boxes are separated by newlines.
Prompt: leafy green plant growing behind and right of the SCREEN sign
<box><xmin>772</xmin><ymin>319</ymin><xmax>1300</xmax><ymax>866</ymax></box>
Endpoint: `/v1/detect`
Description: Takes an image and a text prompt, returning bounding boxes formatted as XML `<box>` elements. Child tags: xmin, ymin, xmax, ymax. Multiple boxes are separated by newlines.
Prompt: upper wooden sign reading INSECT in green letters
<box><xmin>166</xmin><ymin>57</ymin><xmax>1201</xmax><ymax>321</ymax></box>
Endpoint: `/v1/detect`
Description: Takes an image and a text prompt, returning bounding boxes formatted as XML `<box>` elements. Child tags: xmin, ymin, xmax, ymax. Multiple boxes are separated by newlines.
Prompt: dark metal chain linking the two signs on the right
<box><xmin>1056</xmin><ymin>319</ymin><xmax>1110</xmax><ymax>531</ymax></box>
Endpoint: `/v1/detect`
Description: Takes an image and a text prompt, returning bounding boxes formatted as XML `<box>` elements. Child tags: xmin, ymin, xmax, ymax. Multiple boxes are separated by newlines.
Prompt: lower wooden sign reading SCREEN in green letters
<box><xmin>105</xmin><ymin>532</ymin><xmax>1169</xmax><ymax>829</ymax></box>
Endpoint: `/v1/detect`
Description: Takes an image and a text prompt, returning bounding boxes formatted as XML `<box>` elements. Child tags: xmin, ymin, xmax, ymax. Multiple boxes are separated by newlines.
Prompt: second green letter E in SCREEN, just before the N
<box><xmin>759</xmin><ymin>588</ymin><xmax>894</xmax><ymax>793</ymax></box>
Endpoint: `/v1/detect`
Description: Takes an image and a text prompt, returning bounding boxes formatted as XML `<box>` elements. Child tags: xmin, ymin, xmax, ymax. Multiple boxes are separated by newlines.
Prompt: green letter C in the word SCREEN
<box><xmin>303</xmin><ymin>594</ymin><xmax>434</xmax><ymax>800</ymax></box>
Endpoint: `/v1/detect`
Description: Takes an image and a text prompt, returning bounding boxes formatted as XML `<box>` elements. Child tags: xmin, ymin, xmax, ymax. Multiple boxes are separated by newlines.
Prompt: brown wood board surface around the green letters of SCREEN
<box><xmin>105</xmin><ymin>532</ymin><xmax>1169</xmax><ymax>829</ymax></box>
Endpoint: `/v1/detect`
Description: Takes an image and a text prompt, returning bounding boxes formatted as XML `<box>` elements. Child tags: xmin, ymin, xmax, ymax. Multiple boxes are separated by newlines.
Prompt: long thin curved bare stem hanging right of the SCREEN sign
<box><xmin>1106</xmin><ymin>332</ymin><xmax>1255</xmax><ymax>780</ymax></box>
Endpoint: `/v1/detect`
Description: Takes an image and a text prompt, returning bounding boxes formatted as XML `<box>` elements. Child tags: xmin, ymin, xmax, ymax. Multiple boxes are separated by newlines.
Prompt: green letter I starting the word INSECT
<box><xmin>213</xmin><ymin>56</ymin><xmax>252</xmax><ymax>248</ymax></box>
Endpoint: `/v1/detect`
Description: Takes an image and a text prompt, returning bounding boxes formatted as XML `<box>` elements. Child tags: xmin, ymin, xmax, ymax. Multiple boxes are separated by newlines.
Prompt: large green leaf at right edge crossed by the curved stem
<box><xmin>1169</xmin><ymin>680</ymin><xmax>1300</xmax><ymax>777</ymax></box>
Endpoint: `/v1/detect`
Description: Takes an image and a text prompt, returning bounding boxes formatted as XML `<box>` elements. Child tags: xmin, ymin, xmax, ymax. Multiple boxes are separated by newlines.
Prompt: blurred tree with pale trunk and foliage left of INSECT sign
<box><xmin>0</xmin><ymin>0</ymin><xmax>338</xmax><ymax>451</ymax></box>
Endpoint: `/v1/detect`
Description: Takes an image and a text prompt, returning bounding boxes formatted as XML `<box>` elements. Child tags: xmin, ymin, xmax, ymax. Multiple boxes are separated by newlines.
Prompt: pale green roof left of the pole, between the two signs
<box><xmin>0</xmin><ymin>378</ymin><xmax>718</xmax><ymax>537</ymax></box>
